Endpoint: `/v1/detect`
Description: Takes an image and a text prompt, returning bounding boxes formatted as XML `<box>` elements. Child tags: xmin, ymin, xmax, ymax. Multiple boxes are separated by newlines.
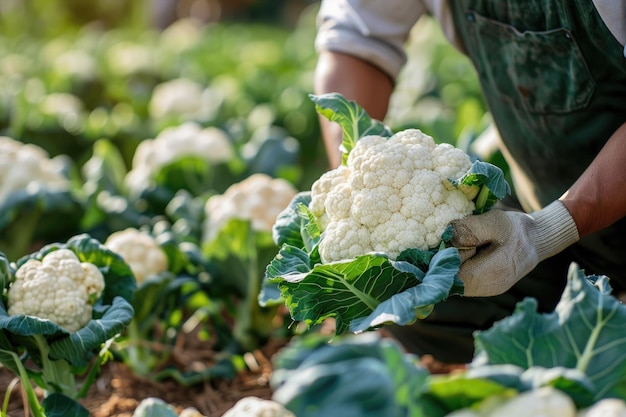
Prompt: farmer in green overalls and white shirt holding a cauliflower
<box><xmin>315</xmin><ymin>0</ymin><xmax>626</xmax><ymax>363</ymax></box>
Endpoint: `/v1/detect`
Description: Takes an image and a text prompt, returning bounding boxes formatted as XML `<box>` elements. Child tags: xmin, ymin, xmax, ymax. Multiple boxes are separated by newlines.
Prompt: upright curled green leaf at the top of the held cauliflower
<box><xmin>309</xmin><ymin>93</ymin><xmax>393</xmax><ymax>165</ymax></box>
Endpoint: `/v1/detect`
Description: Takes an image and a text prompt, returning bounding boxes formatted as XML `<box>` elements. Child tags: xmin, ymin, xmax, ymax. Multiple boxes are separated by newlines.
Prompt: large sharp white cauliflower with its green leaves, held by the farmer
<box><xmin>260</xmin><ymin>94</ymin><xmax>510</xmax><ymax>334</ymax></box>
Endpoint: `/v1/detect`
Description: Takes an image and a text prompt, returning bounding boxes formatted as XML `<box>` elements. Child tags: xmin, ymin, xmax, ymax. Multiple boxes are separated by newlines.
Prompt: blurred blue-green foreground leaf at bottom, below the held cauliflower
<box><xmin>270</xmin><ymin>333</ymin><xmax>428</xmax><ymax>417</ymax></box>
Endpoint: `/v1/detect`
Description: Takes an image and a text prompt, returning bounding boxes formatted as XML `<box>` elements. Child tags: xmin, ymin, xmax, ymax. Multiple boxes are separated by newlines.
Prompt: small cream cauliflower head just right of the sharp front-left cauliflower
<box><xmin>104</xmin><ymin>227</ymin><xmax>168</xmax><ymax>283</ymax></box>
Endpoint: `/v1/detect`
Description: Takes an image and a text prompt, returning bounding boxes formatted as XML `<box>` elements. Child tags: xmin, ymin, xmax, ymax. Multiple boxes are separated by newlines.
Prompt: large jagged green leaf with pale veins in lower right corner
<box><xmin>474</xmin><ymin>264</ymin><xmax>626</xmax><ymax>401</ymax></box>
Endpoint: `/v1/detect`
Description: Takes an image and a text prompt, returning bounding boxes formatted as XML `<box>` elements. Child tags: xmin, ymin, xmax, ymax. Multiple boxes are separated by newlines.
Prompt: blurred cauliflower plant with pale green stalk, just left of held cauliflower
<box><xmin>203</xmin><ymin>173</ymin><xmax>297</xmax><ymax>351</ymax></box>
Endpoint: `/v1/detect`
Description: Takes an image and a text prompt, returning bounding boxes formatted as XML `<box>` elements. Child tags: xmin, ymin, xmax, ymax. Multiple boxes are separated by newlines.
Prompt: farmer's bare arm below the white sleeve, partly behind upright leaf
<box><xmin>315</xmin><ymin>52</ymin><xmax>394</xmax><ymax>168</ymax></box>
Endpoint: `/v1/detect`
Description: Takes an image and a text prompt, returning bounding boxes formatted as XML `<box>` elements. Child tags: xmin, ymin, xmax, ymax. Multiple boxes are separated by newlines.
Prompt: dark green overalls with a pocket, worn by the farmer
<box><xmin>391</xmin><ymin>0</ymin><xmax>626</xmax><ymax>363</ymax></box>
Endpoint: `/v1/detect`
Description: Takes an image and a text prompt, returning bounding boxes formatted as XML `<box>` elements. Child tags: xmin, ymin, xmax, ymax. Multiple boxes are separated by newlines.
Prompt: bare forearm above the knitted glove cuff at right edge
<box><xmin>561</xmin><ymin>123</ymin><xmax>626</xmax><ymax>237</ymax></box>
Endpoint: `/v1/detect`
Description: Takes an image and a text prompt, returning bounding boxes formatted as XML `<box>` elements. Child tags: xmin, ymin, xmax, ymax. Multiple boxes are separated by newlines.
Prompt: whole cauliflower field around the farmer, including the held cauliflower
<box><xmin>0</xmin><ymin>0</ymin><xmax>626</xmax><ymax>417</ymax></box>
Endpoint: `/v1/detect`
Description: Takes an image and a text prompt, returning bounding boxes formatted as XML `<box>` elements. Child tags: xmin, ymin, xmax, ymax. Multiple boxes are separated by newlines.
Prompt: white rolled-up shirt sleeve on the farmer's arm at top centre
<box><xmin>315</xmin><ymin>0</ymin><xmax>427</xmax><ymax>79</ymax></box>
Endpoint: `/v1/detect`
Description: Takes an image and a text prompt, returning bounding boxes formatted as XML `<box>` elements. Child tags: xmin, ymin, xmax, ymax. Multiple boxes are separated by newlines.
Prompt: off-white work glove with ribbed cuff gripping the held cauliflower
<box><xmin>451</xmin><ymin>201</ymin><xmax>579</xmax><ymax>297</ymax></box>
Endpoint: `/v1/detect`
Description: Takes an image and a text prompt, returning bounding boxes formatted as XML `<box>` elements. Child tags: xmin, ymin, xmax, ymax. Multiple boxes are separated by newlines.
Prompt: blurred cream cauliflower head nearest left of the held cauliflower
<box><xmin>204</xmin><ymin>174</ymin><xmax>297</xmax><ymax>241</ymax></box>
